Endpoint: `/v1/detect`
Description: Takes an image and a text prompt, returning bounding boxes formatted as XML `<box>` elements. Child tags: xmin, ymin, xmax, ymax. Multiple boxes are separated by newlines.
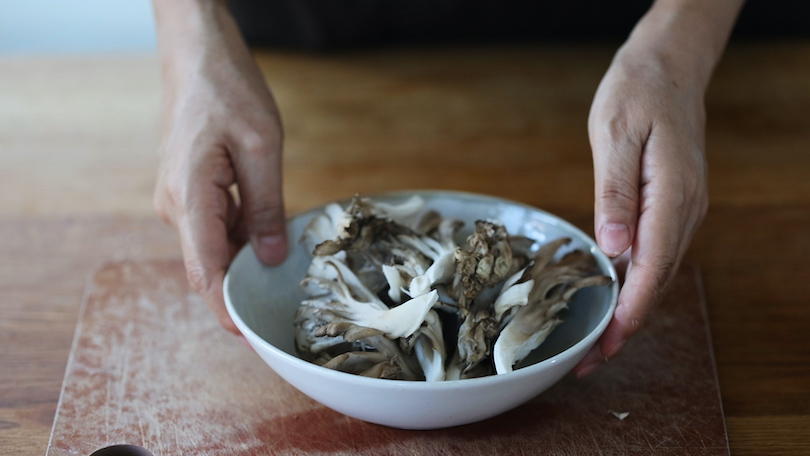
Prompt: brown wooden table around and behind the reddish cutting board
<box><xmin>0</xmin><ymin>42</ymin><xmax>810</xmax><ymax>455</ymax></box>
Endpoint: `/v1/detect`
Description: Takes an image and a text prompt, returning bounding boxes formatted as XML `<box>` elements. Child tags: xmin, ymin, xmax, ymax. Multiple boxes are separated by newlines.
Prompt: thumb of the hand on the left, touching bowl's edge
<box><xmin>234</xmin><ymin>132</ymin><xmax>287</xmax><ymax>265</ymax></box>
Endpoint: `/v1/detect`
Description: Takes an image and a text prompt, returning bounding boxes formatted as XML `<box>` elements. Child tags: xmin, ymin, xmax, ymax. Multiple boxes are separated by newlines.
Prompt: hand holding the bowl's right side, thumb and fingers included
<box><xmin>574</xmin><ymin>40</ymin><xmax>708</xmax><ymax>377</ymax></box>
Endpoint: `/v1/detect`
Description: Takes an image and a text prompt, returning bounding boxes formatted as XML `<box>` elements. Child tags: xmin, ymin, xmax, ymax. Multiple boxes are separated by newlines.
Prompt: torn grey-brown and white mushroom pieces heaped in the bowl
<box><xmin>295</xmin><ymin>196</ymin><xmax>611</xmax><ymax>381</ymax></box>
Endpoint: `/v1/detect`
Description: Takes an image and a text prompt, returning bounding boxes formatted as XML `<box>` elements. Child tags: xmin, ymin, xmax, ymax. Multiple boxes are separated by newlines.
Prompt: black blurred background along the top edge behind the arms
<box><xmin>226</xmin><ymin>0</ymin><xmax>810</xmax><ymax>50</ymax></box>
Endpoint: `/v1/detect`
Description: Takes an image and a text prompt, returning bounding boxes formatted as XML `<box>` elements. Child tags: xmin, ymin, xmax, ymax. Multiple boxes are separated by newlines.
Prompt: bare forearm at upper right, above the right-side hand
<box><xmin>622</xmin><ymin>0</ymin><xmax>744</xmax><ymax>90</ymax></box>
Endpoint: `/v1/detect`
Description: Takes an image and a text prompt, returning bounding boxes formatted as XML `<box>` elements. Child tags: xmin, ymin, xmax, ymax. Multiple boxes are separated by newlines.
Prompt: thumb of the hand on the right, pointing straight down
<box><xmin>590</xmin><ymin>118</ymin><xmax>644</xmax><ymax>257</ymax></box>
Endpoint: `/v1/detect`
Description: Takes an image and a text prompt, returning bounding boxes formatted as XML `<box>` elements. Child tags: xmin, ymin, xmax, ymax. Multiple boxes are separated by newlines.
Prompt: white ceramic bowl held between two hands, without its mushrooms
<box><xmin>224</xmin><ymin>191</ymin><xmax>618</xmax><ymax>429</ymax></box>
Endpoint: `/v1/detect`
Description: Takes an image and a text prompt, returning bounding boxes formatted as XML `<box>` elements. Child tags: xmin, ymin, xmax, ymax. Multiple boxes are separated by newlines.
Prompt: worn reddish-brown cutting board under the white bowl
<box><xmin>47</xmin><ymin>260</ymin><xmax>729</xmax><ymax>456</ymax></box>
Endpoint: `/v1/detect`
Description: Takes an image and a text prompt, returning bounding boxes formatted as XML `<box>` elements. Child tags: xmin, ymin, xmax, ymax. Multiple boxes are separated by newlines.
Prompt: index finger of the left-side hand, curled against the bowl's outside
<box><xmin>177</xmin><ymin>179</ymin><xmax>239</xmax><ymax>334</ymax></box>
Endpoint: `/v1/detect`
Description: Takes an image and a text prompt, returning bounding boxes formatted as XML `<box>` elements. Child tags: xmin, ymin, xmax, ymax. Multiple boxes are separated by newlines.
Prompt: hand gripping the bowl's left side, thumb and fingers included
<box><xmin>154</xmin><ymin>0</ymin><xmax>287</xmax><ymax>334</ymax></box>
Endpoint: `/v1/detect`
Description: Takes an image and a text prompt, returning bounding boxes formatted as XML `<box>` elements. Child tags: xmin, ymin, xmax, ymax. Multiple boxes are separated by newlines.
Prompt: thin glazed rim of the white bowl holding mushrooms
<box><xmin>222</xmin><ymin>190</ymin><xmax>619</xmax><ymax>390</ymax></box>
